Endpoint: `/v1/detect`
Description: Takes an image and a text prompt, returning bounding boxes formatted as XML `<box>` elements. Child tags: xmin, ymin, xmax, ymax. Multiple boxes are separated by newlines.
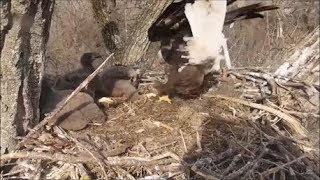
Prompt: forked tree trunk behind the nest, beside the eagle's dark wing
<box><xmin>91</xmin><ymin>0</ymin><xmax>172</xmax><ymax>64</ymax></box>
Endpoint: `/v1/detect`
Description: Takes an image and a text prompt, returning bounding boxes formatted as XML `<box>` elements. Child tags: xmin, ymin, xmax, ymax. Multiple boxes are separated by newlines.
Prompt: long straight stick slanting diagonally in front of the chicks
<box><xmin>16</xmin><ymin>53</ymin><xmax>114</xmax><ymax>149</ymax></box>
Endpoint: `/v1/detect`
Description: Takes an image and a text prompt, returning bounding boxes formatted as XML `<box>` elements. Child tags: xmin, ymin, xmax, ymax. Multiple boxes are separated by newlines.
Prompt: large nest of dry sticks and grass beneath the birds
<box><xmin>1</xmin><ymin>30</ymin><xmax>320</xmax><ymax>179</ymax></box>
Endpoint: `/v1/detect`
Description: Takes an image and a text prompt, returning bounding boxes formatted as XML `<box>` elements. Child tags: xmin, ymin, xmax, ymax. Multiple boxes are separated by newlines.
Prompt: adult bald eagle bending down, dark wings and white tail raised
<box><xmin>148</xmin><ymin>0</ymin><xmax>277</xmax><ymax>96</ymax></box>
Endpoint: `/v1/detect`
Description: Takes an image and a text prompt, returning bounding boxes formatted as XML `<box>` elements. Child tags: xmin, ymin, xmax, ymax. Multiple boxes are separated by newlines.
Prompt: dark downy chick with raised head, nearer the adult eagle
<box><xmin>55</xmin><ymin>53</ymin><xmax>140</xmax><ymax>100</ymax></box>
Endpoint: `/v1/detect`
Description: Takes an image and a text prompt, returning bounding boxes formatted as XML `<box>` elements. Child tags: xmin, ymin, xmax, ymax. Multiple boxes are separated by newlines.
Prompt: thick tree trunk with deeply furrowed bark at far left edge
<box><xmin>0</xmin><ymin>0</ymin><xmax>54</xmax><ymax>153</ymax></box>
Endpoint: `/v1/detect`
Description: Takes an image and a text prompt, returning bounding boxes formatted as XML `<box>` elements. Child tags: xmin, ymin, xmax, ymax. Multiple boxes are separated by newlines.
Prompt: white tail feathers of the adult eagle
<box><xmin>184</xmin><ymin>0</ymin><xmax>227</xmax><ymax>65</ymax></box>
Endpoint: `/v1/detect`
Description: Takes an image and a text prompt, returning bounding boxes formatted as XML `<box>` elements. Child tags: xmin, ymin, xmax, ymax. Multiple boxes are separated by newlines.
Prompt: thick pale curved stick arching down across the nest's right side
<box><xmin>208</xmin><ymin>95</ymin><xmax>307</xmax><ymax>137</ymax></box>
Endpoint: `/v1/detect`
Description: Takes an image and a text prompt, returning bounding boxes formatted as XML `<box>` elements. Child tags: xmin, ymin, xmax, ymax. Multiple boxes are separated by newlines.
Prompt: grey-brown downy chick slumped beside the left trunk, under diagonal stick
<box><xmin>40</xmin><ymin>76</ymin><xmax>106</xmax><ymax>131</ymax></box>
